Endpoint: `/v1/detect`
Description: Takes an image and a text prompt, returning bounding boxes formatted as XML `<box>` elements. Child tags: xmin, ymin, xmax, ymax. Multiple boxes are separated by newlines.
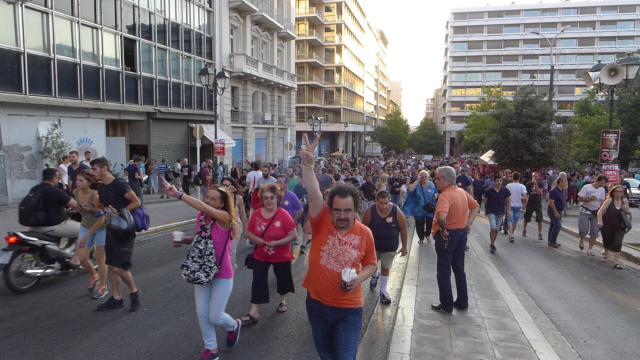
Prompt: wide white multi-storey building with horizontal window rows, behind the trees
<box><xmin>439</xmin><ymin>0</ymin><xmax>640</xmax><ymax>155</ymax></box>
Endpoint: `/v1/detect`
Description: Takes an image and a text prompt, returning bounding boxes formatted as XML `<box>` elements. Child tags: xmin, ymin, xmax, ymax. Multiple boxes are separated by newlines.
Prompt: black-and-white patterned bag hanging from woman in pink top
<box><xmin>180</xmin><ymin>213</ymin><xmax>233</xmax><ymax>285</ymax></box>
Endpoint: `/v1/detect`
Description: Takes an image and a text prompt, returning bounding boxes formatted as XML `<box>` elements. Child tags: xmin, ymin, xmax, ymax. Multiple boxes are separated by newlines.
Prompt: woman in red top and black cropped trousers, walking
<box><xmin>242</xmin><ymin>184</ymin><xmax>298</xmax><ymax>324</ymax></box>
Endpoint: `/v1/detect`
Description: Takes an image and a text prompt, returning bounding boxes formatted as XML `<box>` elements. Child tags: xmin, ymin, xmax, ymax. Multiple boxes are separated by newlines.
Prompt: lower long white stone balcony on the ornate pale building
<box><xmin>229</xmin><ymin>53</ymin><xmax>297</xmax><ymax>88</ymax></box>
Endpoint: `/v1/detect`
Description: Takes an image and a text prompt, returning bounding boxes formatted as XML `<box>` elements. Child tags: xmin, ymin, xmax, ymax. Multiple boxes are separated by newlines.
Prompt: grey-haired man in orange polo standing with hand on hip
<box><xmin>431</xmin><ymin>166</ymin><xmax>479</xmax><ymax>314</ymax></box>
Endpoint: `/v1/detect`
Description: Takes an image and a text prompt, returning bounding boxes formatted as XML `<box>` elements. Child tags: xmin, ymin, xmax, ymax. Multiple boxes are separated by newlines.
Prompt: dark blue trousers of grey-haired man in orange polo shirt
<box><xmin>434</xmin><ymin>229</ymin><xmax>469</xmax><ymax>311</ymax></box>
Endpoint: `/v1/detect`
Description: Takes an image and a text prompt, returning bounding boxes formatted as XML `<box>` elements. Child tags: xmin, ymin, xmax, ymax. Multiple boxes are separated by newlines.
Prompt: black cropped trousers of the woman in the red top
<box><xmin>251</xmin><ymin>258</ymin><xmax>296</xmax><ymax>304</ymax></box>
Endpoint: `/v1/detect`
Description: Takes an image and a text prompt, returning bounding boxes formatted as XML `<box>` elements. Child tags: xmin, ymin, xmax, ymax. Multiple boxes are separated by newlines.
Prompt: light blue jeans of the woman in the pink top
<box><xmin>194</xmin><ymin>278</ymin><xmax>236</xmax><ymax>350</ymax></box>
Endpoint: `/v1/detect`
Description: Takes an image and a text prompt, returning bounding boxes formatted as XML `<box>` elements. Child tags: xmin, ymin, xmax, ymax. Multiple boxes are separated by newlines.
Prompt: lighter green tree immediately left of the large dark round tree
<box><xmin>461</xmin><ymin>86</ymin><xmax>508</xmax><ymax>153</ymax></box>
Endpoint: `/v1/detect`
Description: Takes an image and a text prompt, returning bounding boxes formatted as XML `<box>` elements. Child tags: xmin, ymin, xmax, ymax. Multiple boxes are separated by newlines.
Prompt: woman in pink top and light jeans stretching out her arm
<box><xmin>162</xmin><ymin>179</ymin><xmax>241</xmax><ymax>360</ymax></box>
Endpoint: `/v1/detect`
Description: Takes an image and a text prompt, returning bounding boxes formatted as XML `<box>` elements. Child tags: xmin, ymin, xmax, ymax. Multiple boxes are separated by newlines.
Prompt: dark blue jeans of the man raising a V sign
<box><xmin>306</xmin><ymin>292</ymin><xmax>362</xmax><ymax>360</ymax></box>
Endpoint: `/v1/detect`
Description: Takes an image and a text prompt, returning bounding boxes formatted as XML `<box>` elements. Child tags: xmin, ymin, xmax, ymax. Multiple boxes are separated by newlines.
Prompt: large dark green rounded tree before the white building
<box><xmin>489</xmin><ymin>85</ymin><xmax>557</xmax><ymax>169</ymax></box>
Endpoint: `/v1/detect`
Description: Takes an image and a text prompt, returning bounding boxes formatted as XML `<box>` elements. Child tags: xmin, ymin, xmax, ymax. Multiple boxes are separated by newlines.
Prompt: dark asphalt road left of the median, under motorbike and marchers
<box><xmin>0</xmin><ymin>227</ymin><xmax>377</xmax><ymax>360</ymax></box>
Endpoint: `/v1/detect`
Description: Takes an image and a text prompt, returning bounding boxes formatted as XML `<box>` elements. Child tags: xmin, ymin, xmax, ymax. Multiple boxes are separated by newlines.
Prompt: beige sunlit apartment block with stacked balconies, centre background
<box><xmin>295</xmin><ymin>0</ymin><xmax>389</xmax><ymax>156</ymax></box>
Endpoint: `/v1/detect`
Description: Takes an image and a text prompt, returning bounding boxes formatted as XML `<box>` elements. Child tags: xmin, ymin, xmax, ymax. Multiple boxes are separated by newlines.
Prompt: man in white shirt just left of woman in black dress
<box><xmin>578</xmin><ymin>175</ymin><xmax>609</xmax><ymax>256</ymax></box>
